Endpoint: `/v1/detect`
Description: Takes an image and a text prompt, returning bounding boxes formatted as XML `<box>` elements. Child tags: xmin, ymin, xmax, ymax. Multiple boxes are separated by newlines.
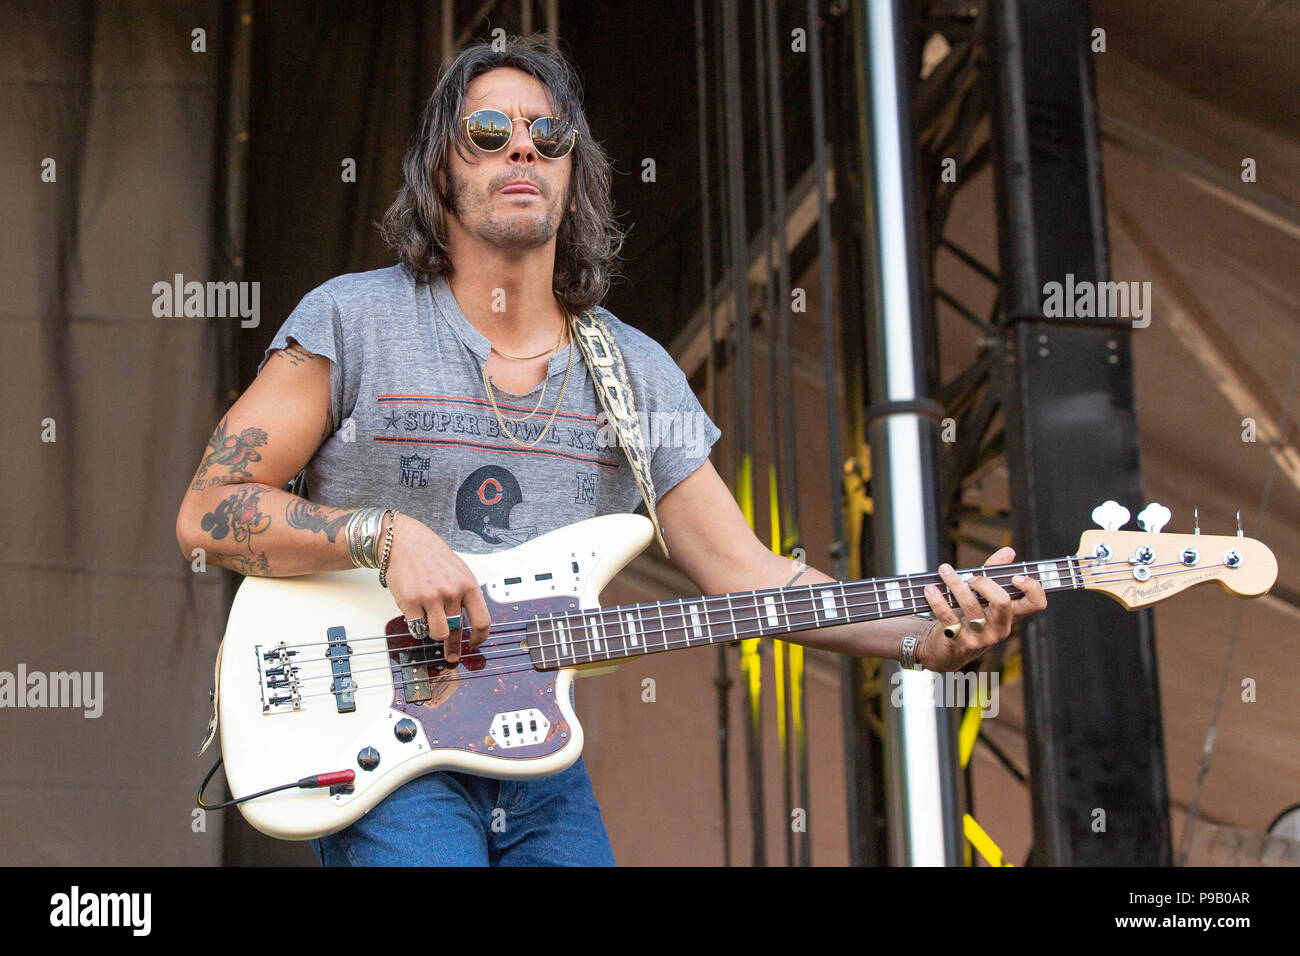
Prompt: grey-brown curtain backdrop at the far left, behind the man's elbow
<box><xmin>0</xmin><ymin>0</ymin><xmax>228</xmax><ymax>865</ymax></box>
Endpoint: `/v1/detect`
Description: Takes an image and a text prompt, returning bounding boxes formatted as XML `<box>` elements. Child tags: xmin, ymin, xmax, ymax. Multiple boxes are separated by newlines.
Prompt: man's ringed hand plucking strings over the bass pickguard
<box><xmin>381</xmin><ymin>514</ymin><xmax>491</xmax><ymax>663</ymax></box>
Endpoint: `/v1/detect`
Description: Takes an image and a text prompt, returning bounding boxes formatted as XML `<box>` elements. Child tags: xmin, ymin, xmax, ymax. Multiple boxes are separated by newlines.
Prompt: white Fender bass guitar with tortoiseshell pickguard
<box><xmin>209</xmin><ymin>502</ymin><xmax>1278</xmax><ymax>840</ymax></box>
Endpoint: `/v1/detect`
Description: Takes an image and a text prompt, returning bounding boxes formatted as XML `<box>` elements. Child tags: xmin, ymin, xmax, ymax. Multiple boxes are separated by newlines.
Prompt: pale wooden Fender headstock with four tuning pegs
<box><xmin>1078</xmin><ymin>501</ymin><xmax>1278</xmax><ymax>610</ymax></box>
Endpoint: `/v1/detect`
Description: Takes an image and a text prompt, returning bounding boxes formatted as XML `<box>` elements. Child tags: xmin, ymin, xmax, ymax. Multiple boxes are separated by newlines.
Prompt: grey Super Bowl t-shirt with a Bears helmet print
<box><xmin>259</xmin><ymin>265</ymin><xmax>722</xmax><ymax>554</ymax></box>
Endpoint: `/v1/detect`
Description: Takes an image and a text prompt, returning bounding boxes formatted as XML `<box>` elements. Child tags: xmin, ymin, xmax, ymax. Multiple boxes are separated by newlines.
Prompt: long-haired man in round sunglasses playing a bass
<box><xmin>177</xmin><ymin>36</ymin><xmax>1047</xmax><ymax>865</ymax></box>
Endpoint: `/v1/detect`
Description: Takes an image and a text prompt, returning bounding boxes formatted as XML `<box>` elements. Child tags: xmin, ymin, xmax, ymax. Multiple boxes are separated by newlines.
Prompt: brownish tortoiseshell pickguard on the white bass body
<box><xmin>385</xmin><ymin>589</ymin><xmax>579</xmax><ymax>760</ymax></box>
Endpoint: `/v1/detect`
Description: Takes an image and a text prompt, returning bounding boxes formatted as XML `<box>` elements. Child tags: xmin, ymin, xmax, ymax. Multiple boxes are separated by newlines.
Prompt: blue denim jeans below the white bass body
<box><xmin>312</xmin><ymin>757</ymin><xmax>614</xmax><ymax>866</ymax></box>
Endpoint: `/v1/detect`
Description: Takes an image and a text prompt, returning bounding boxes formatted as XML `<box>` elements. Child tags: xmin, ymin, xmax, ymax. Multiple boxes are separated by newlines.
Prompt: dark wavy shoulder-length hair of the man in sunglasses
<box><xmin>380</xmin><ymin>34</ymin><xmax>625</xmax><ymax>311</ymax></box>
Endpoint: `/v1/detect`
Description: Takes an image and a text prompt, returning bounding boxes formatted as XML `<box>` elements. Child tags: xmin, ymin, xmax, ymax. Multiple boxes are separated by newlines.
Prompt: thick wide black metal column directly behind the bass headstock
<box><xmin>991</xmin><ymin>0</ymin><xmax>1173</xmax><ymax>866</ymax></box>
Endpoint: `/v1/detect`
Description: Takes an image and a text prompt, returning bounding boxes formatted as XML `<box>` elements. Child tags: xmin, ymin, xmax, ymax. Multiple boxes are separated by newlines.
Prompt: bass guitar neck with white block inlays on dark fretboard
<box><xmin>528</xmin><ymin>555</ymin><xmax>1084</xmax><ymax>670</ymax></box>
